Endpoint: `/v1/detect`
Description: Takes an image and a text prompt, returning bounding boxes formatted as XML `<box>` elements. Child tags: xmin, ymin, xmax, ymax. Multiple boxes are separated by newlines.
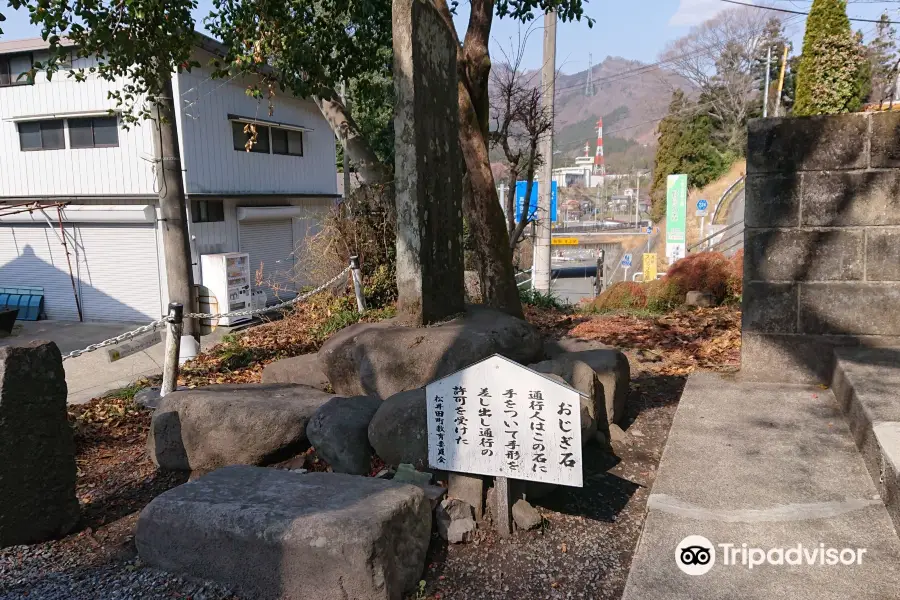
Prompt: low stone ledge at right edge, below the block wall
<box><xmin>831</xmin><ymin>348</ymin><xmax>900</xmax><ymax>531</ymax></box>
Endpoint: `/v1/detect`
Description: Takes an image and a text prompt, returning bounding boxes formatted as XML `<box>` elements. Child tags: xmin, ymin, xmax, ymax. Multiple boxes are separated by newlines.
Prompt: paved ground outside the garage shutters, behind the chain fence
<box><xmin>0</xmin><ymin>321</ymin><xmax>229</xmax><ymax>404</ymax></box>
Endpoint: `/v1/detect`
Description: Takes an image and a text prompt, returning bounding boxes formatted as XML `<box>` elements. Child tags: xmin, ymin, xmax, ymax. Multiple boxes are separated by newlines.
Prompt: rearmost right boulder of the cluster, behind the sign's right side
<box><xmin>531</xmin><ymin>345</ymin><xmax>631</xmax><ymax>426</ymax></box>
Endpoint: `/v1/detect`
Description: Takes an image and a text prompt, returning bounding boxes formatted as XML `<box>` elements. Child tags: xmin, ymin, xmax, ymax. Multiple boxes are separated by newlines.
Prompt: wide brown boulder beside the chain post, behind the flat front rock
<box><xmin>147</xmin><ymin>384</ymin><xmax>333</xmax><ymax>471</ymax></box>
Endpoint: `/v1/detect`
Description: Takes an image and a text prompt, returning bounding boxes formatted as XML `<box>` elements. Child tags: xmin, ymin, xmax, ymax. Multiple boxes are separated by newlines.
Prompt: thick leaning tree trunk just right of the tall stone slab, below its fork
<box><xmin>459</xmin><ymin>82</ymin><xmax>523</xmax><ymax>317</ymax></box>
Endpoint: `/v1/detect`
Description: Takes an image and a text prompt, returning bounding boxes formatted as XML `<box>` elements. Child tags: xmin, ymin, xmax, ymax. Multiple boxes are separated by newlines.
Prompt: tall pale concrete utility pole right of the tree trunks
<box><xmin>531</xmin><ymin>10</ymin><xmax>556</xmax><ymax>293</ymax></box>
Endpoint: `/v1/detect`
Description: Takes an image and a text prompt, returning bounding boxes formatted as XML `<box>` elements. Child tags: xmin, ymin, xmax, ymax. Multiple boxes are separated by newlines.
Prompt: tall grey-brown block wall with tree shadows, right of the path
<box><xmin>741</xmin><ymin>113</ymin><xmax>900</xmax><ymax>383</ymax></box>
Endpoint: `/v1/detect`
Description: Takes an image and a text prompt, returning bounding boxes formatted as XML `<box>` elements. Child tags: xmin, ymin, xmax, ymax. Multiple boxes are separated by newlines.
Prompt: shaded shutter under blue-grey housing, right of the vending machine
<box><xmin>240</xmin><ymin>219</ymin><xmax>297</xmax><ymax>300</ymax></box>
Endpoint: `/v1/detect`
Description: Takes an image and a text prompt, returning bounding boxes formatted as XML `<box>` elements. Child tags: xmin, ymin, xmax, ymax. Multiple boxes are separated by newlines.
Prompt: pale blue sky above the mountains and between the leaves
<box><xmin>0</xmin><ymin>0</ymin><xmax>900</xmax><ymax>73</ymax></box>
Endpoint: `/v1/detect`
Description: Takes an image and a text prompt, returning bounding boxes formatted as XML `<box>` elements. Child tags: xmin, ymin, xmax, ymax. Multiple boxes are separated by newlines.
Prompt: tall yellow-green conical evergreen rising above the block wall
<box><xmin>794</xmin><ymin>0</ymin><xmax>868</xmax><ymax>116</ymax></box>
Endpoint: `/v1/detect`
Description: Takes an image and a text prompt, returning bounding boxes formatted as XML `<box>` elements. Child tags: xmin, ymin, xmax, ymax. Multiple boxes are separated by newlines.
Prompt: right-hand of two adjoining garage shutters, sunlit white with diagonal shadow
<box><xmin>76</xmin><ymin>223</ymin><xmax>162</xmax><ymax>322</ymax></box>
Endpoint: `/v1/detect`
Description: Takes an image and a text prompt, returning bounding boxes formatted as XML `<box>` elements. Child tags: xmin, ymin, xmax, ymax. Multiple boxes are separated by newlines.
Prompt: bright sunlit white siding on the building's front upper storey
<box><xmin>0</xmin><ymin>61</ymin><xmax>154</xmax><ymax>198</ymax></box>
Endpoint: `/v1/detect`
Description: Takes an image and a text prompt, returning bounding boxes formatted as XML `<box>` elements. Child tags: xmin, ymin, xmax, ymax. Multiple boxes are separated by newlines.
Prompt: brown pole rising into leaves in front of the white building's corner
<box><xmin>154</xmin><ymin>69</ymin><xmax>200</xmax><ymax>362</ymax></box>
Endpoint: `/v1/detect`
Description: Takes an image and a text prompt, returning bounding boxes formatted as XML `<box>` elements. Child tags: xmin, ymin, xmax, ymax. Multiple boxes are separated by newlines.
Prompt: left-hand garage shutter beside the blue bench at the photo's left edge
<box><xmin>0</xmin><ymin>225</ymin><xmax>78</xmax><ymax>321</ymax></box>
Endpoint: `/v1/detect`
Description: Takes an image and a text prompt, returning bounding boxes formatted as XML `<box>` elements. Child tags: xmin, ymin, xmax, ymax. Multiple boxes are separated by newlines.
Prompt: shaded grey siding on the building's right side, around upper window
<box><xmin>176</xmin><ymin>55</ymin><xmax>337</xmax><ymax>194</ymax></box>
